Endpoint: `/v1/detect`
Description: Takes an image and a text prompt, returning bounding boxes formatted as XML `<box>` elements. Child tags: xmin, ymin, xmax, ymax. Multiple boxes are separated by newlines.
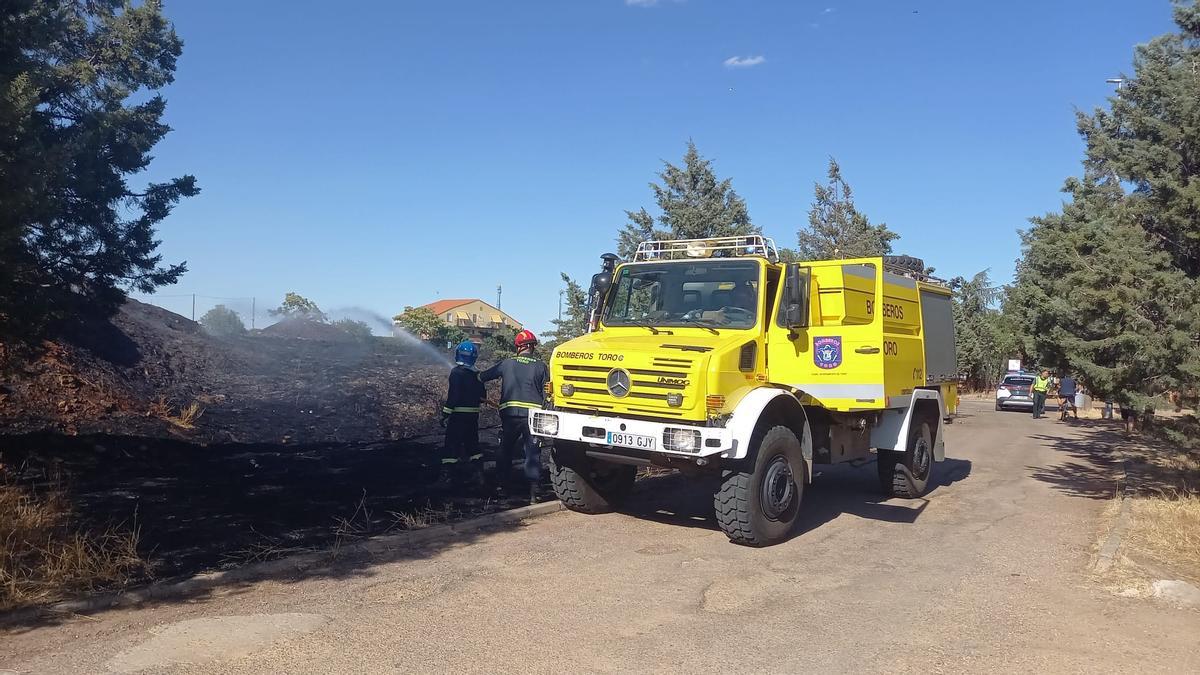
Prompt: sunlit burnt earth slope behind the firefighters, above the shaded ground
<box><xmin>0</xmin><ymin>300</ymin><xmax>477</xmax><ymax>443</ymax></box>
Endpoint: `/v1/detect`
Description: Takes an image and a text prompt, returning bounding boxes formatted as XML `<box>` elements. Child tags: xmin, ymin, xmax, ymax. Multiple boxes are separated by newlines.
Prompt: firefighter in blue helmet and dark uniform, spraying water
<box><xmin>438</xmin><ymin>340</ymin><xmax>486</xmax><ymax>484</ymax></box>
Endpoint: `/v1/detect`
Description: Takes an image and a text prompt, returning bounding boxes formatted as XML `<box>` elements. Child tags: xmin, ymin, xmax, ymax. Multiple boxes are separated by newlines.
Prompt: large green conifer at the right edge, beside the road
<box><xmin>1006</xmin><ymin>1</ymin><xmax>1200</xmax><ymax>406</ymax></box>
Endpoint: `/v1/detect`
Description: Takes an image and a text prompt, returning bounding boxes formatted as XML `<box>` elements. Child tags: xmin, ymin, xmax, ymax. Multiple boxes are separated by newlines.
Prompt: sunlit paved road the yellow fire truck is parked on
<box><xmin>0</xmin><ymin>402</ymin><xmax>1200</xmax><ymax>673</ymax></box>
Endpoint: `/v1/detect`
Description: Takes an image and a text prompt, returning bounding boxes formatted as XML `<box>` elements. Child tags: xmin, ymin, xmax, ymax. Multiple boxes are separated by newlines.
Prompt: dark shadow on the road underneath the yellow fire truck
<box><xmin>620</xmin><ymin>458</ymin><xmax>971</xmax><ymax>538</ymax></box>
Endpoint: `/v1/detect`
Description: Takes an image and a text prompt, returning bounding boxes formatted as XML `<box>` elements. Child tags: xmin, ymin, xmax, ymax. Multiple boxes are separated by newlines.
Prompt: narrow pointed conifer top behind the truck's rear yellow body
<box><xmin>788</xmin><ymin>157</ymin><xmax>900</xmax><ymax>261</ymax></box>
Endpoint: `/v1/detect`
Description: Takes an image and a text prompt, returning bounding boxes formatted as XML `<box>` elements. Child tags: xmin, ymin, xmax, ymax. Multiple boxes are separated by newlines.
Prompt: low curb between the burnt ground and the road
<box><xmin>0</xmin><ymin>500</ymin><xmax>566</xmax><ymax>627</ymax></box>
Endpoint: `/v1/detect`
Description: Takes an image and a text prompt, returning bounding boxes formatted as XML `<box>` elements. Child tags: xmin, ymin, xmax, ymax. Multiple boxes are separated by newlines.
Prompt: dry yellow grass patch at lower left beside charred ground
<box><xmin>0</xmin><ymin>467</ymin><xmax>150</xmax><ymax>611</ymax></box>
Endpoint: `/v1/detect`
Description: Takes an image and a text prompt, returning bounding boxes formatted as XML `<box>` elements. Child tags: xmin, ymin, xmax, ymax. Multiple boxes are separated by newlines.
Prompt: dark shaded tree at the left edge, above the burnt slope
<box><xmin>0</xmin><ymin>0</ymin><xmax>198</xmax><ymax>334</ymax></box>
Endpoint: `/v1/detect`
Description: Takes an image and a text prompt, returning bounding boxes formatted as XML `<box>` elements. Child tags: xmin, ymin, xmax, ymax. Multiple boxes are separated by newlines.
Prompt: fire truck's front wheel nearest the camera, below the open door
<box><xmin>713</xmin><ymin>426</ymin><xmax>805</xmax><ymax>546</ymax></box>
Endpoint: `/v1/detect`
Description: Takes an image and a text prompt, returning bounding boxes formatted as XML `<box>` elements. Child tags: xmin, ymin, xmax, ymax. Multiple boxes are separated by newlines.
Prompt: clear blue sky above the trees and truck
<box><xmin>131</xmin><ymin>0</ymin><xmax>1174</xmax><ymax>330</ymax></box>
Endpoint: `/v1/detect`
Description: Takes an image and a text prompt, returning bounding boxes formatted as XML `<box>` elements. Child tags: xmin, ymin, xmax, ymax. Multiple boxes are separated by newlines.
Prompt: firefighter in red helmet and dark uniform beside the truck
<box><xmin>479</xmin><ymin>330</ymin><xmax>550</xmax><ymax>502</ymax></box>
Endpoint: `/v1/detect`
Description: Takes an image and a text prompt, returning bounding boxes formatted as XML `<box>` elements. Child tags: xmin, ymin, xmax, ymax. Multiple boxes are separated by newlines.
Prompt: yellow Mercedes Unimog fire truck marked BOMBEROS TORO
<box><xmin>530</xmin><ymin>237</ymin><xmax>958</xmax><ymax>545</ymax></box>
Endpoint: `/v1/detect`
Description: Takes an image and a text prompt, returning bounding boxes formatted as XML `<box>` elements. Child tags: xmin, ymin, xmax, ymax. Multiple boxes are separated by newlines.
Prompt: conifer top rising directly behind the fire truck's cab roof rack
<box><xmin>617</xmin><ymin>141</ymin><xmax>761</xmax><ymax>258</ymax></box>
